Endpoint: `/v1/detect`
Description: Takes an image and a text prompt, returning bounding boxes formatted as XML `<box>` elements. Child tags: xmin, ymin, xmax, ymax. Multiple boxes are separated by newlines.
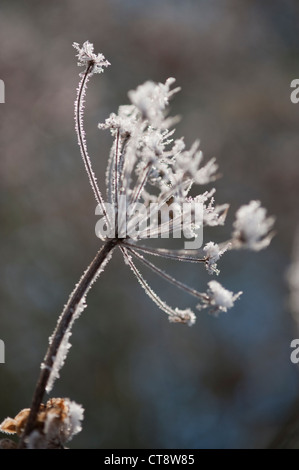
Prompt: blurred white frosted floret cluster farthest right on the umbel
<box><xmin>233</xmin><ymin>201</ymin><xmax>274</xmax><ymax>251</ymax></box>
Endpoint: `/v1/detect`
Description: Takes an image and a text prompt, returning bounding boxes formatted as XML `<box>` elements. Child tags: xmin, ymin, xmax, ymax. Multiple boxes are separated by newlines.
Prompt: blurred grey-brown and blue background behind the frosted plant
<box><xmin>0</xmin><ymin>0</ymin><xmax>299</xmax><ymax>449</ymax></box>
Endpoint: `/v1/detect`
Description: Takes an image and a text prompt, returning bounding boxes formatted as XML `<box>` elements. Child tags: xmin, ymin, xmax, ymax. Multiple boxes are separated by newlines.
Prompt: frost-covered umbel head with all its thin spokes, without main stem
<box><xmin>74</xmin><ymin>42</ymin><xmax>273</xmax><ymax>325</ymax></box>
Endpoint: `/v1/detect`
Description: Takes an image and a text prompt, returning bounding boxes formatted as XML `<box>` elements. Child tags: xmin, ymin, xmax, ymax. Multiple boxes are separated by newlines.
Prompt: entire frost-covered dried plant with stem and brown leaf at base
<box><xmin>0</xmin><ymin>41</ymin><xmax>274</xmax><ymax>448</ymax></box>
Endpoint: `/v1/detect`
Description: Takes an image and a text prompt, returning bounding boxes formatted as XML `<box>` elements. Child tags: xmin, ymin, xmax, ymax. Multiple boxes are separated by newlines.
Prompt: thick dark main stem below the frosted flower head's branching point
<box><xmin>19</xmin><ymin>239</ymin><xmax>119</xmax><ymax>448</ymax></box>
